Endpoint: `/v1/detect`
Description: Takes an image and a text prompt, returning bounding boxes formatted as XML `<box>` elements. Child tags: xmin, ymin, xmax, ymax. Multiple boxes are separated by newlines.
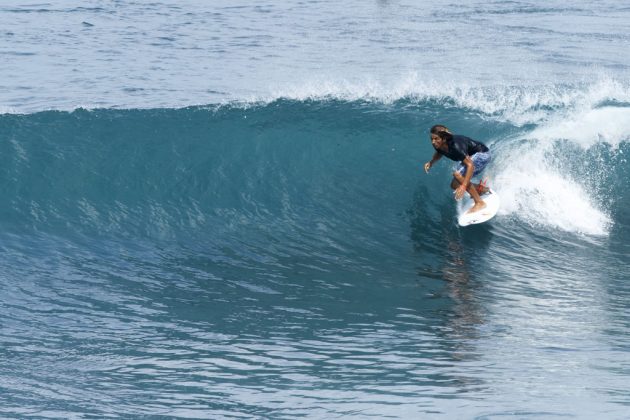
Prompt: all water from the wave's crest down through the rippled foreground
<box><xmin>0</xmin><ymin>81</ymin><xmax>630</xmax><ymax>418</ymax></box>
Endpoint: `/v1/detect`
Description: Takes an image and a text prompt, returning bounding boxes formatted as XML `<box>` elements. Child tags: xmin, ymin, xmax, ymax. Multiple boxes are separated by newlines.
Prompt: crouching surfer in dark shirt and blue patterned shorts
<box><xmin>424</xmin><ymin>124</ymin><xmax>491</xmax><ymax>213</ymax></box>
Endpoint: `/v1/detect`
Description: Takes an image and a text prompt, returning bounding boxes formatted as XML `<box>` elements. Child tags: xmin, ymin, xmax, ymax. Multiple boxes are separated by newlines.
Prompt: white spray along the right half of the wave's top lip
<box><xmin>262</xmin><ymin>73</ymin><xmax>630</xmax><ymax>126</ymax></box>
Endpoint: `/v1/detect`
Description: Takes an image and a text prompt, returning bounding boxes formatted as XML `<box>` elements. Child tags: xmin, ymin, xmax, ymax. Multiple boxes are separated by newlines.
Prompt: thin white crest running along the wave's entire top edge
<box><xmin>0</xmin><ymin>72</ymin><xmax>630</xmax><ymax>126</ymax></box>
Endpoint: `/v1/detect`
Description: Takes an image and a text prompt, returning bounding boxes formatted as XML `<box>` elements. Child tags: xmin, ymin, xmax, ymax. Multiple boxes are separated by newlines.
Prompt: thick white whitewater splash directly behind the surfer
<box><xmin>494</xmin><ymin>80</ymin><xmax>630</xmax><ymax>235</ymax></box>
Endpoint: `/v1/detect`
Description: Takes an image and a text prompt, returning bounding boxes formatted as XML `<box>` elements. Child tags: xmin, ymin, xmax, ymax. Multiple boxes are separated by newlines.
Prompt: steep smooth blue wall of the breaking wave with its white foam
<box><xmin>0</xmin><ymin>93</ymin><xmax>630</xmax><ymax>243</ymax></box>
